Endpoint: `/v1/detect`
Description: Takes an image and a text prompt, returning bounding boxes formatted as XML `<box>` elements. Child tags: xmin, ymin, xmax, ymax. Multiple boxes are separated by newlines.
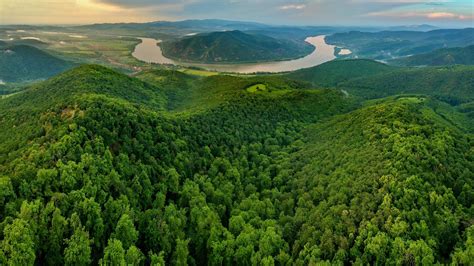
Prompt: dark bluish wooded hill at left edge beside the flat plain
<box><xmin>0</xmin><ymin>45</ymin><xmax>73</xmax><ymax>82</ymax></box>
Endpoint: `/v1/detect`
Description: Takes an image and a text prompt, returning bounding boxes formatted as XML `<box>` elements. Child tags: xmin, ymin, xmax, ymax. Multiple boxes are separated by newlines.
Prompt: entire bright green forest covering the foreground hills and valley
<box><xmin>0</xmin><ymin>66</ymin><xmax>474</xmax><ymax>265</ymax></box>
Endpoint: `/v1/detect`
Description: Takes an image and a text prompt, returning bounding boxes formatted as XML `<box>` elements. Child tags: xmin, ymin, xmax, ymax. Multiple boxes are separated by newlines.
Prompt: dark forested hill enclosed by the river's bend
<box><xmin>161</xmin><ymin>31</ymin><xmax>314</xmax><ymax>63</ymax></box>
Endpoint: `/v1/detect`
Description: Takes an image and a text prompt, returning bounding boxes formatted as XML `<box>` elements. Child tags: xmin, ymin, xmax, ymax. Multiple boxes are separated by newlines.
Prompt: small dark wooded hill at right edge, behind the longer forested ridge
<box><xmin>391</xmin><ymin>45</ymin><xmax>474</xmax><ymax>66</ymax></box>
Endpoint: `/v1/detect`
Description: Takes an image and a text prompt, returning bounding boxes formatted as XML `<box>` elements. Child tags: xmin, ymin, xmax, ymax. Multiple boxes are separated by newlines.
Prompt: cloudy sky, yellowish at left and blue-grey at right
<box><xmin>0</xmin><ymin>0</ymin><xmax>474</xmax><ymax>27</ymax></box>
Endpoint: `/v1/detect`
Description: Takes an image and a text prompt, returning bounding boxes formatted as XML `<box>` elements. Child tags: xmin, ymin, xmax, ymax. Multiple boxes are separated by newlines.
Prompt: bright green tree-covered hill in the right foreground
<box><xmin>291</xmin><ymin>98</ymin><xmax>474</xmax><ymax>265</ymax></box>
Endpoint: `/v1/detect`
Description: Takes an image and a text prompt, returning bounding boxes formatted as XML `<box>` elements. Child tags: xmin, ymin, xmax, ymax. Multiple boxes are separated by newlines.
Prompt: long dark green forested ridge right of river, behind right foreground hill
<box><xmin>284</xmin><ymin>59</ymin><xmax>474</xmax><ymax>105</ymax></box>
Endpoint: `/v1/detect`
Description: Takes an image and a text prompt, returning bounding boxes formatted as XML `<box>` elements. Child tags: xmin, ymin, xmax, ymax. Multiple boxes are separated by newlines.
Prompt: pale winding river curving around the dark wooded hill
<box><xmin>132</xmin><ymin>35</ymin><xmax>346</xmax><ymax>74</ymax></box>
